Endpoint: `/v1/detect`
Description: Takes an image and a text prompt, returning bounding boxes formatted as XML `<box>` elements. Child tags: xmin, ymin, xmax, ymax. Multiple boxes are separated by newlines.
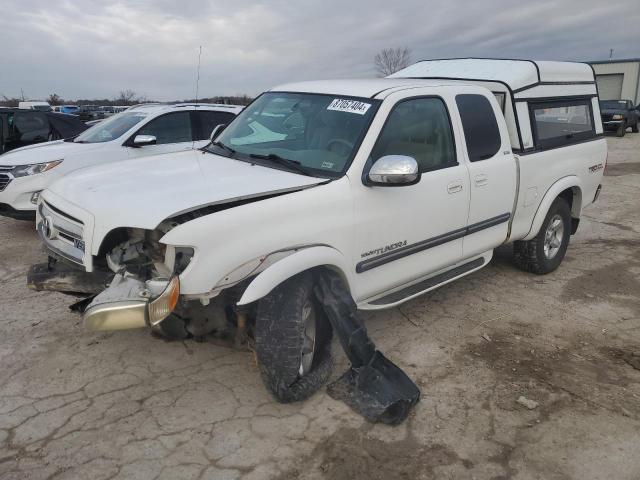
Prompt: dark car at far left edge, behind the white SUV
<box><xmin>0</xmin><ymin>108</ymin><xmax>88</xmax><ymax>154</ymax></box>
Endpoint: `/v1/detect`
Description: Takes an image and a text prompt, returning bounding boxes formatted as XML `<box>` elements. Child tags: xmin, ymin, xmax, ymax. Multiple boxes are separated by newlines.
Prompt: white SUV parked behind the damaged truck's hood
<box><xmin>0</xmin><ymin>104</ymin><xmax>244</xmax><ymax>219</ymax></box>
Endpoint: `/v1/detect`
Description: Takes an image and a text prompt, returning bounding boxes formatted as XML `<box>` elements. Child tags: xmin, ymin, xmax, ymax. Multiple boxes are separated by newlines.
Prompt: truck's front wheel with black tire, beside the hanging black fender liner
<box><xmin>255</xmin><ymin>272</ymin><xmax>332</xmax><ymax>403</ymax></box>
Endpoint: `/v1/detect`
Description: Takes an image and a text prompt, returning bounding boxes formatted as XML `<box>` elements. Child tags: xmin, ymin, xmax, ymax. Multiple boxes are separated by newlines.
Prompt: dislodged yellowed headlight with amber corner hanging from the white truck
<box><xmin>83</xmin><ymin>274</ymin><xmax>180</xmax><ymax>330</ymax></box>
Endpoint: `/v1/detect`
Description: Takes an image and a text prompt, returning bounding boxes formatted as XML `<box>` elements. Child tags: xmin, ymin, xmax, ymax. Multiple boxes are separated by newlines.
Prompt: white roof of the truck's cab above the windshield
<box><xmin>271</xmin><ymin>78</ymin><xmax>464</xmax><ymax>98</ymax></box>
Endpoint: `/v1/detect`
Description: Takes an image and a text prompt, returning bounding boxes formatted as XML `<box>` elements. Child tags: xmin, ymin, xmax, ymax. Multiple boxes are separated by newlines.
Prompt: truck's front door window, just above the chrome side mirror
<box><xmin>371</xmin><ymin>98</ymin><xmax>456</xmax><ymax>172</ymax></box>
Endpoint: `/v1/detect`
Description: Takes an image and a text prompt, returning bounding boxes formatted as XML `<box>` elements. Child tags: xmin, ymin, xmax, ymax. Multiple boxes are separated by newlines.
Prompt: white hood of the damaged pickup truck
<box><xmin>49</xmin><ymin>150</ymin><xmax>326</xmax><ymax>232</ymax></box>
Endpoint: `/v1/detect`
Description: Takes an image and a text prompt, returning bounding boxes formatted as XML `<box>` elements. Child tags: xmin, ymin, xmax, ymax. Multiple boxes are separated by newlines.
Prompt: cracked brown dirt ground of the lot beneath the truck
<box><xmin>0</xmin><ymin>134</ymin><xmax>640</xmax><ymax>480</ymax></box>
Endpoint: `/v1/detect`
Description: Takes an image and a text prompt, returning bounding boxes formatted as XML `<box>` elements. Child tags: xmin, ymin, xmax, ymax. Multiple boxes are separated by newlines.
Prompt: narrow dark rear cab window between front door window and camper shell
<box><xmin>456</xmin><ymin>94</ymin><xmax>502</xmax><ymax>162</ymax></box>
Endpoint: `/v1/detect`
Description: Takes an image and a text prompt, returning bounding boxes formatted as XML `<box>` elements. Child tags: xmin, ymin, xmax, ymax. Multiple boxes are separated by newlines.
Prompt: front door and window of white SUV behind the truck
<box><xmin>125</xmin><ymin>110</ymin><xmax>193</xmax><ymax>158</ymax></box>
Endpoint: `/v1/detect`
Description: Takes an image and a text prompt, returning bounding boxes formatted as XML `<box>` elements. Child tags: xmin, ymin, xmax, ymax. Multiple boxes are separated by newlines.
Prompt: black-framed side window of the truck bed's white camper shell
<box><xmin>529</xmin><ymin>99</ymin><xmax>596</xmax><ymax>148</ymax></box>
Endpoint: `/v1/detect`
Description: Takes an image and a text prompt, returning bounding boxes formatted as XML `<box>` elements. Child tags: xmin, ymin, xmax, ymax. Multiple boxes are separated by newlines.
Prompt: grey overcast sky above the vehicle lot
<box><xmin>0</xmin><ymin>0</ymin><xmax>640</xmax><ymax>100</ymax></box>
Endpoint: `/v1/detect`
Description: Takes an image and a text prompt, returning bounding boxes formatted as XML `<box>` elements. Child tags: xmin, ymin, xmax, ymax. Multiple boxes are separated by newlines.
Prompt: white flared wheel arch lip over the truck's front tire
<box><xmin>238</xmin><ymin>246</ymin><xmax>349</xmax><ymax>305</ymax></box>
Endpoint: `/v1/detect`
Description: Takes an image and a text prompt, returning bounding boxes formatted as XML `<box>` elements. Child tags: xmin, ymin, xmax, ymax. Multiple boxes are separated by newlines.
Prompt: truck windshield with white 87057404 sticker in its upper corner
<box><xmin>207</xmin><ymin>92</ymin><xmax>379</xmax><ymax>177</ymax></box>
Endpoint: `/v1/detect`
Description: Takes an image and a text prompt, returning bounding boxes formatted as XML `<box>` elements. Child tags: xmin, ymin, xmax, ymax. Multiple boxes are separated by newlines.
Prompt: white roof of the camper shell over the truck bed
<box><xmin>388</xmin><ymin>58</ymin><xmax>595</xmax><ymax>91</ymax></box>
